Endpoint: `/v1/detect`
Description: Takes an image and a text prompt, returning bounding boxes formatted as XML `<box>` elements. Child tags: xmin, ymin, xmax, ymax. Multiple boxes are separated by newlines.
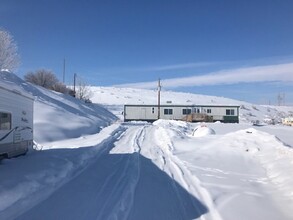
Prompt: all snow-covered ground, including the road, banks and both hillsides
<box><xmin>0</xmin><ymin>73</ymin><xmax>293</xmax><ymax>220</ymax></box>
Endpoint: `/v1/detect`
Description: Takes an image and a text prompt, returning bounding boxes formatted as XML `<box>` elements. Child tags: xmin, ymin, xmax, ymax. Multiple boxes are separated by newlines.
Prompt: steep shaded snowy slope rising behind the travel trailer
<box><xmin>0</xmin><ymin>71</ymin><xmax>117</xmax><ymax>143</ymax></box>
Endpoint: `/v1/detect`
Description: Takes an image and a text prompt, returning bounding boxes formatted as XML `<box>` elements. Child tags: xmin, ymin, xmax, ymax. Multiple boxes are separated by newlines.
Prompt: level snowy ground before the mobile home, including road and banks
<box><xmin>0</xmin><ymin>120</ymin><xmax>293</xmax><ymax>220</ymax></box>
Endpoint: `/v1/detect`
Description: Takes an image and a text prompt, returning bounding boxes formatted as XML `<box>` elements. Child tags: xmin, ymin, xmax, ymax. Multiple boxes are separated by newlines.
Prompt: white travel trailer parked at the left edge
<box><xmin>0</xmin><ymin>82</ymin><xmax>34</xmax><ymax>158</ymax></box>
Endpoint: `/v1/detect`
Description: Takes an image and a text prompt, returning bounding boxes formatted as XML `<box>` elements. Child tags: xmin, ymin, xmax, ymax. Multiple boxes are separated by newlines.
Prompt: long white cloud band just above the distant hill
<box><xmin>116</xmin><ymin>63</ymin><xmax>293</xmax><ymax>89</ymax></box>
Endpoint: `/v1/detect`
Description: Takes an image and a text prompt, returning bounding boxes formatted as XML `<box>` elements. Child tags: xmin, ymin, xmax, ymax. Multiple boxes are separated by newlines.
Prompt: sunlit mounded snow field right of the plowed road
<box><xmin>162</xmin><ymin>123</ymin><xmax>293</xmax><ymax>220</ymax></box>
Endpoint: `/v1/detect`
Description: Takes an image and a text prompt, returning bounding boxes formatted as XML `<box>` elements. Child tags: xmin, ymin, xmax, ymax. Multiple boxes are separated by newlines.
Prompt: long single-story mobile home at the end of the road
<box><xmin>123</xmin><ymin>105</ymin><xmax>239</xmax><ymax>123</ymax></box>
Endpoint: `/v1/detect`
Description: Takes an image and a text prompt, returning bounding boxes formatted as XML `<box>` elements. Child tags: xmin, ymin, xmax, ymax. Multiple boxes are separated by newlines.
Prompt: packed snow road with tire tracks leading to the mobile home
<box><xmin>6</xmin><ymin>125</ymin><xmax>208</xmax><ymax>220</ymax></box>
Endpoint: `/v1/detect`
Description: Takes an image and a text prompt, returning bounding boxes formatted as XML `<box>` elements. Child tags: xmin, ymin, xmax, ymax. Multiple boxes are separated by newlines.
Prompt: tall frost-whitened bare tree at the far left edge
<box><xmin>0</xmin><ymin>28</ymin><xmax>20</xmax><ymax>71</ymax></box>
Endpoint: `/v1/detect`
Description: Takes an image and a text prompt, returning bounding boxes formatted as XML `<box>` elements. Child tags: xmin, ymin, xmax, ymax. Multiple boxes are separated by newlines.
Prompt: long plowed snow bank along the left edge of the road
<box><xmin>0</xmin><ymin>124</ymin><xmax>123</xmax><ymax>219</ymax></box>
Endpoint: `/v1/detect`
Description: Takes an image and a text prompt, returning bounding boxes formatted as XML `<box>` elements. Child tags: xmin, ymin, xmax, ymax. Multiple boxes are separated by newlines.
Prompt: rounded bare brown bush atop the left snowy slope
<box><xmin>24</xmin><ymin>69</ymin><xmax>59</xmax><ymax>90</ymax></box>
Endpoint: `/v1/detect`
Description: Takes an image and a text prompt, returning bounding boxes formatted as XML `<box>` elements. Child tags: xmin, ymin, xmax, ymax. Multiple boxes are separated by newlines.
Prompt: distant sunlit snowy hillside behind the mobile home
<box><xmin>91</xmin><ymin>87</ymin><xmax>293</xmax><ymax>123</ymax></box>
